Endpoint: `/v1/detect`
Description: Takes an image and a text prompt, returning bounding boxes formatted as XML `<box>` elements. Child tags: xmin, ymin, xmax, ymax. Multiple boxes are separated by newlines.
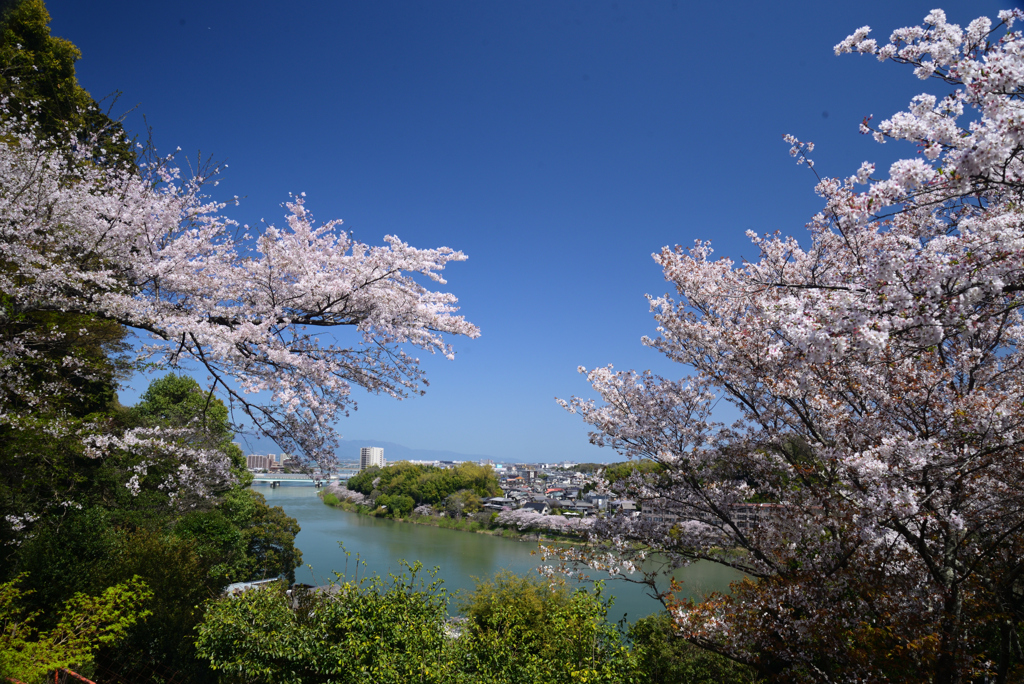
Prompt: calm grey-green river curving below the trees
<box><xmin>264</xmin><ymin>485</ymin><xmax>742</xmax><ymax>622</ymax></box>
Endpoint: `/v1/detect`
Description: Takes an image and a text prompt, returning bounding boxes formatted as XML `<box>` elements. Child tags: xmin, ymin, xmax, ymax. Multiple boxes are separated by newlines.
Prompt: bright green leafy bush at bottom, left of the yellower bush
<box><xmin>197</xmin><ymin>564</ymin><xmax>453</xmax><ymax>684</ymax></box>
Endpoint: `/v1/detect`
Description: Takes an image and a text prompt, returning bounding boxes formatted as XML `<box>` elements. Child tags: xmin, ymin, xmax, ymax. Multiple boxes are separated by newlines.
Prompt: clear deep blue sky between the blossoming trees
<box><xmin>47</xmin><ymin>0</ymin><xmax>1007</xmax><ymax>461</ymax></box>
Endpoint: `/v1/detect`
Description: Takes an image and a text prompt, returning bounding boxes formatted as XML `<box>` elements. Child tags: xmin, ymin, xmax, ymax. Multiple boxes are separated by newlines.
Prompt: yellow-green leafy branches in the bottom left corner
<box><xmin>0</xmin><ymin>578</ymin><xmax>153</xmax><ymax>683</ymax></box>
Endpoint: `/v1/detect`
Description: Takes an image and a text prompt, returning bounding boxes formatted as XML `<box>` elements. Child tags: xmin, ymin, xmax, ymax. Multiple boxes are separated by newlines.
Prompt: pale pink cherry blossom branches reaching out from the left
<box><xmin>0</xmin><ymin>113</ymin><xmax>478</xmax><ymax>481</ymax></box>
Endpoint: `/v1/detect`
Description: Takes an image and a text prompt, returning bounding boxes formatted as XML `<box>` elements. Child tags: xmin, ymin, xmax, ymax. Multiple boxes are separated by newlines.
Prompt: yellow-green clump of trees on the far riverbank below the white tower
<box><xmin>348</xmin><ymin>461</ymin><xmax>502</xmax><ymax>510</ymax></box>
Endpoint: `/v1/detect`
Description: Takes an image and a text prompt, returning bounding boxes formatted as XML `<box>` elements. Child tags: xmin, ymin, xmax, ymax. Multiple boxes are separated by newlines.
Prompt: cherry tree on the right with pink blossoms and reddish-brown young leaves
<box><xmin>562</xmin><ymin>10</ymin><xmax>1024</xmax><ymax>683</ymax></box>
